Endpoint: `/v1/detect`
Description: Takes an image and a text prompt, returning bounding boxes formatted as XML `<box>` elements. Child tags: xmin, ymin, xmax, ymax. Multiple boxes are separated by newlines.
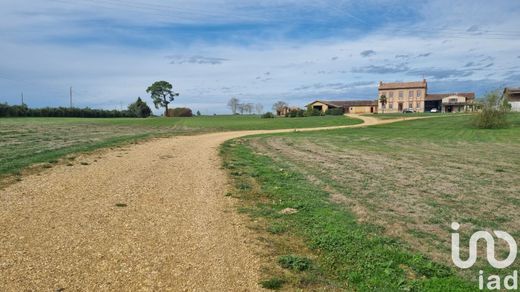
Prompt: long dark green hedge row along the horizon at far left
<box><xmin>0</xmin><ymin>103</ymin><xmax>135</xmax><ymax>118</ymax></box>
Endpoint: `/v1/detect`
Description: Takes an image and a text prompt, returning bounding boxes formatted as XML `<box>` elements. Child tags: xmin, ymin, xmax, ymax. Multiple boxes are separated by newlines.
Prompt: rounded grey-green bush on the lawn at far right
<box><xmin>474</xmin><ymin>91</ymin><xmax>511</xmax><ymax>129</ymax></box>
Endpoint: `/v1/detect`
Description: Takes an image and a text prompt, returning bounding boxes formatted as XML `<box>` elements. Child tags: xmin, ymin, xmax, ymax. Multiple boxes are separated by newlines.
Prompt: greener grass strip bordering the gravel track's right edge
<box><xmin>221</xmin><ymin>139</ymin><xmax>474</xmax><ymax>291</ymax></box>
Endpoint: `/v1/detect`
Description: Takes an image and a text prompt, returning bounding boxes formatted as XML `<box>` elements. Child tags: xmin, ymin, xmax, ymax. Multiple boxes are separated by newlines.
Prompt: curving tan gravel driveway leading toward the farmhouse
<box><xmin>0</xmin><ymin>113</ymin><xmax>414</xmax><ymax>291</ymax></box>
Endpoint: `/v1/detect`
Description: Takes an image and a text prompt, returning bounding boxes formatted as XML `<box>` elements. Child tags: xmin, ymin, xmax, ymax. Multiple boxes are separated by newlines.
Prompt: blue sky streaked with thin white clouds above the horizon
<box><xmin>0</xmin><ymin>0</ymin><xmax>520</xmax><ymax>114</ymax></box>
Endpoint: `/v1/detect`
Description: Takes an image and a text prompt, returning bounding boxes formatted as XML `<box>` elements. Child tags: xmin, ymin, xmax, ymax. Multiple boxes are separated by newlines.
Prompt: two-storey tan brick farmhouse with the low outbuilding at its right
<box><xmin>378</xmin><ymin>79</ymin><xmax>475</xmax><ymax>113</ymax></box>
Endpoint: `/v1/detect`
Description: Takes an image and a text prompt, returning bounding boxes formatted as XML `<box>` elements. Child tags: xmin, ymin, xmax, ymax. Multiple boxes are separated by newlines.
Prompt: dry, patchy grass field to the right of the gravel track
<box><xmin>222</xmin><ymin>115</ymin><xmax>520</xmax><ymax>291</ymax></box>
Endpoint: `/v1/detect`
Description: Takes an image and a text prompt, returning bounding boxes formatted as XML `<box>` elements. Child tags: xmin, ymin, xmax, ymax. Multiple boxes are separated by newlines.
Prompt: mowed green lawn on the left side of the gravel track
<box><xmin>0</xmin><ymin>116</ymin><xmax>360</xmax><ymax>175</ymax></box>
